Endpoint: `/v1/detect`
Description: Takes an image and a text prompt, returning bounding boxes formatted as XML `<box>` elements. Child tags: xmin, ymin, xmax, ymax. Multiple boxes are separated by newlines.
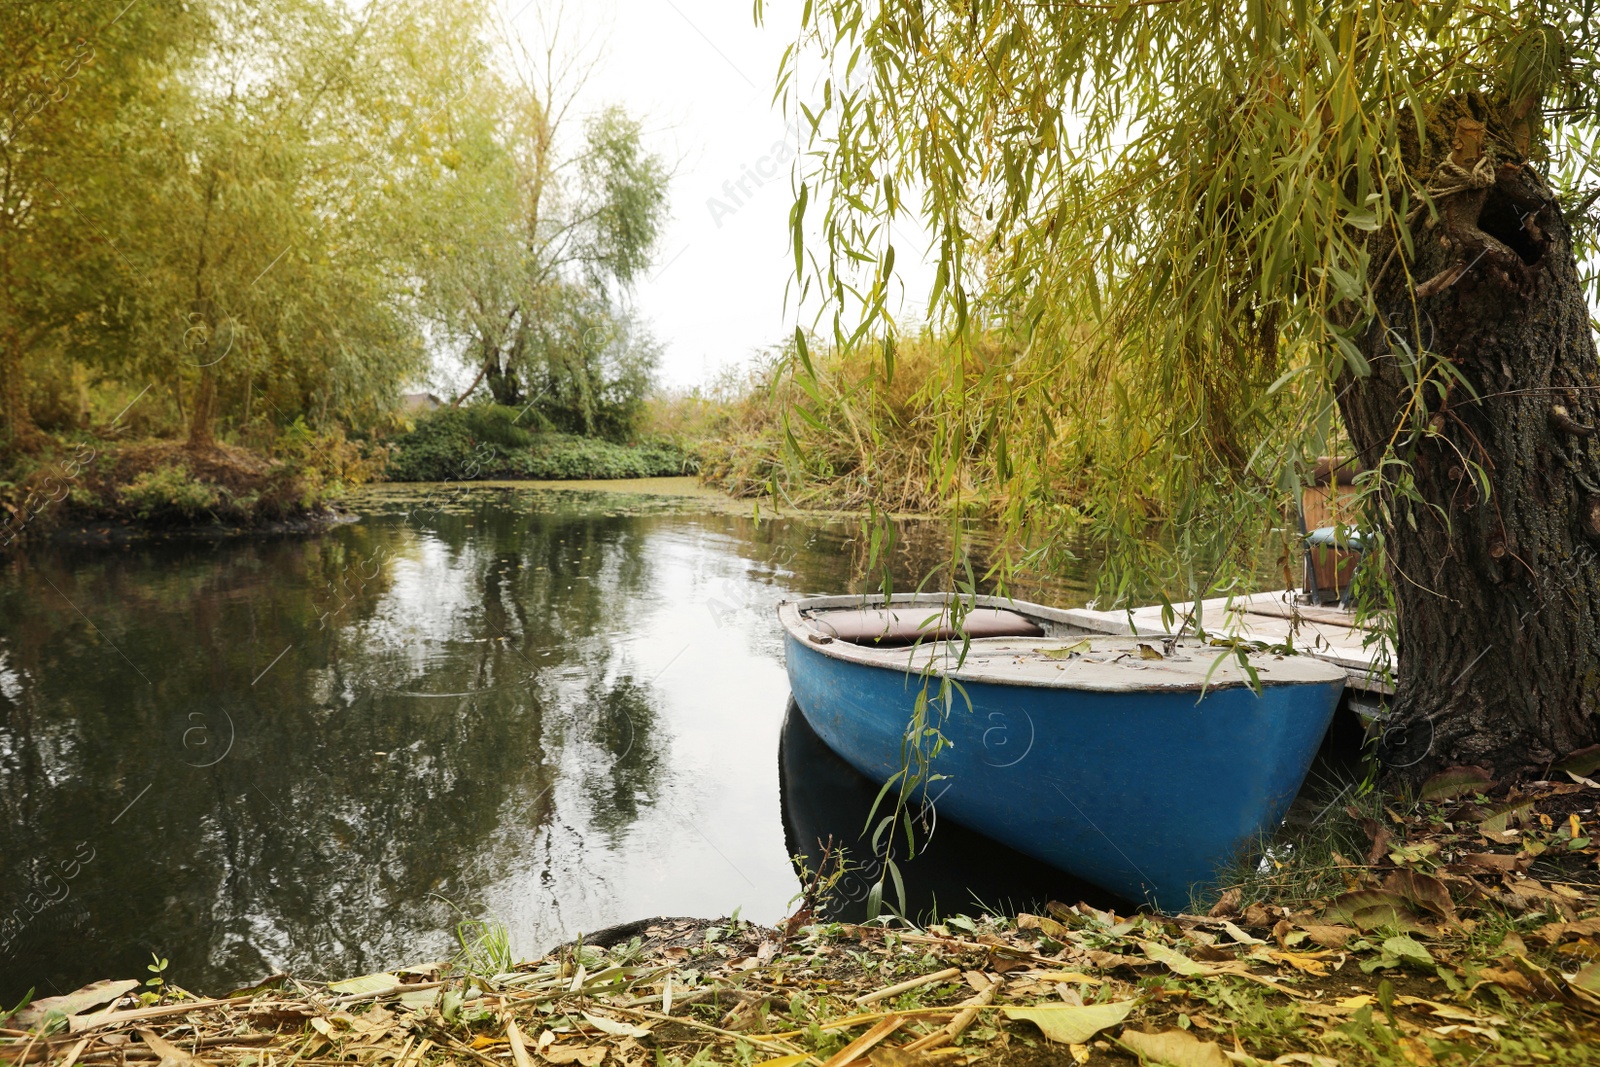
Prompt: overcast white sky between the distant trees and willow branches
<box><xmin>510</xmin><ymin>0</ymin><xmax>920</xmax><ymax>387</ymax></box>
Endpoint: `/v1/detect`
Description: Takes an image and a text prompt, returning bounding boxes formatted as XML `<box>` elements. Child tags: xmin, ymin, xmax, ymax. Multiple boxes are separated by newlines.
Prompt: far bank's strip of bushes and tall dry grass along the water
<box><xmin>0</xmin><ymin>341</ymin><xmax>1024</xmax><ymax>550</ymax></box>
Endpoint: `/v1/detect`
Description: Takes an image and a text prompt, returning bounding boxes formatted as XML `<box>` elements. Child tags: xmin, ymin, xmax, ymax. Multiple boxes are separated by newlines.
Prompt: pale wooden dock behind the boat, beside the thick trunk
<box><xmin>1062</xmin><ymin>589</ymin><xmax>1394</xmax><ymax>697</ymax></box>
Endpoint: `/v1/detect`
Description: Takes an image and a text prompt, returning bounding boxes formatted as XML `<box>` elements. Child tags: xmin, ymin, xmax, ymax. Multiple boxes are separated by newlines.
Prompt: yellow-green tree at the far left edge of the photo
<box><xmin>0</xmin><ymin>0</ymin><xmax>208</xmax><ymax>450</ymax></box>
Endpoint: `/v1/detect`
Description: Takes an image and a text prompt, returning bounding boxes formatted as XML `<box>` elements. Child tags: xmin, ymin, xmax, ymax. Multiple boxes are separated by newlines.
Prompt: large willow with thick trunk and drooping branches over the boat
<box><xmin>779</xmin><ymin>0</ymin><xmax>1600</xmax><ymax>776</ymax></box>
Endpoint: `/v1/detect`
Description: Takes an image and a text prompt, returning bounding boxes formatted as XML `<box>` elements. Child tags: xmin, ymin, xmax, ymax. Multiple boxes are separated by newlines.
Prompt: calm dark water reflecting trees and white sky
<box><xmin>0</xmin><ymin>483</ymin><xmax>1086</xmax><ymax>998</ymax></box>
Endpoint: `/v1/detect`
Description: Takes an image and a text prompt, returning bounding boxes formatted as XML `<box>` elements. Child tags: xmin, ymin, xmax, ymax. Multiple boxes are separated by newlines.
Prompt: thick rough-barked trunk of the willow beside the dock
<box><xmin>1339</xmin><ymin>102</ymin><xmax>1600</xmax><ymax>781</ymax></box>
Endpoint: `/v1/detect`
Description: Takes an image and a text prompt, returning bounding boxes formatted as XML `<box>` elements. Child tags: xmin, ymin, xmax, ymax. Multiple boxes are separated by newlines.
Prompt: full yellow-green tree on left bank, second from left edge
<box><xmin>123</xmin><ymin>0</ymin><xmax>427</xmax><ymax>448</ymax></box>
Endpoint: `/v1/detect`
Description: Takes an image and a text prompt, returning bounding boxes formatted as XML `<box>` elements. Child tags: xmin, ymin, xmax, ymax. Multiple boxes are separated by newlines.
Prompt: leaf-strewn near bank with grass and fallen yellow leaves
<box><xmin>9</xmin><ymin>750</ymin><xmax>1600</xmax><ymax>1067</ymax></box>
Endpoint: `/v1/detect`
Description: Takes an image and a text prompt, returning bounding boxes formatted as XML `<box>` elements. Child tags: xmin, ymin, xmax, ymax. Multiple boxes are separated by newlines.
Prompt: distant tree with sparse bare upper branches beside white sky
<box><xmin>424</xmin><ymin>10</ymin><xmax>669</xmax><ymax>435</ymax></box>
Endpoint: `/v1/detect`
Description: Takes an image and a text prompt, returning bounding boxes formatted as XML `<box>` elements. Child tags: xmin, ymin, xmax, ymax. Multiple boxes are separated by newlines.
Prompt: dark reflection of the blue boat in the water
<box><xmin>778</xmin><ymin>697</ymin><xmax>1113</xmax><ymax>921</ymax></box>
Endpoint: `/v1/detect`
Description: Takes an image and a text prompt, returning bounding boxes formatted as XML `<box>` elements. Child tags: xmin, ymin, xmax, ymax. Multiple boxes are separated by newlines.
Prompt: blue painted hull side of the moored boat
<box><xmin>786</xmin><ymin>632</ymin><xmax>1342</xmax><ymax>910</ymax></box>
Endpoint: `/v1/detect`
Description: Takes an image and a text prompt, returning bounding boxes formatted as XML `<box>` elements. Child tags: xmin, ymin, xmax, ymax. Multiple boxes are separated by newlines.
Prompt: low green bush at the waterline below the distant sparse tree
<box><xmin>386</xmin><ymin>405</ymin><xmax>693</xmax><ymax>482</ymax></box>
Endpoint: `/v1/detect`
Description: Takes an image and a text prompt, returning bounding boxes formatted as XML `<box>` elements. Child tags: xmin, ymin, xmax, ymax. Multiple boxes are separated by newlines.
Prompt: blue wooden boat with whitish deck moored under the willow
<box><xmin>778</xmin><ymin>593</ymin><xmax>1346</xmax><ymax>910</ymax></box>
